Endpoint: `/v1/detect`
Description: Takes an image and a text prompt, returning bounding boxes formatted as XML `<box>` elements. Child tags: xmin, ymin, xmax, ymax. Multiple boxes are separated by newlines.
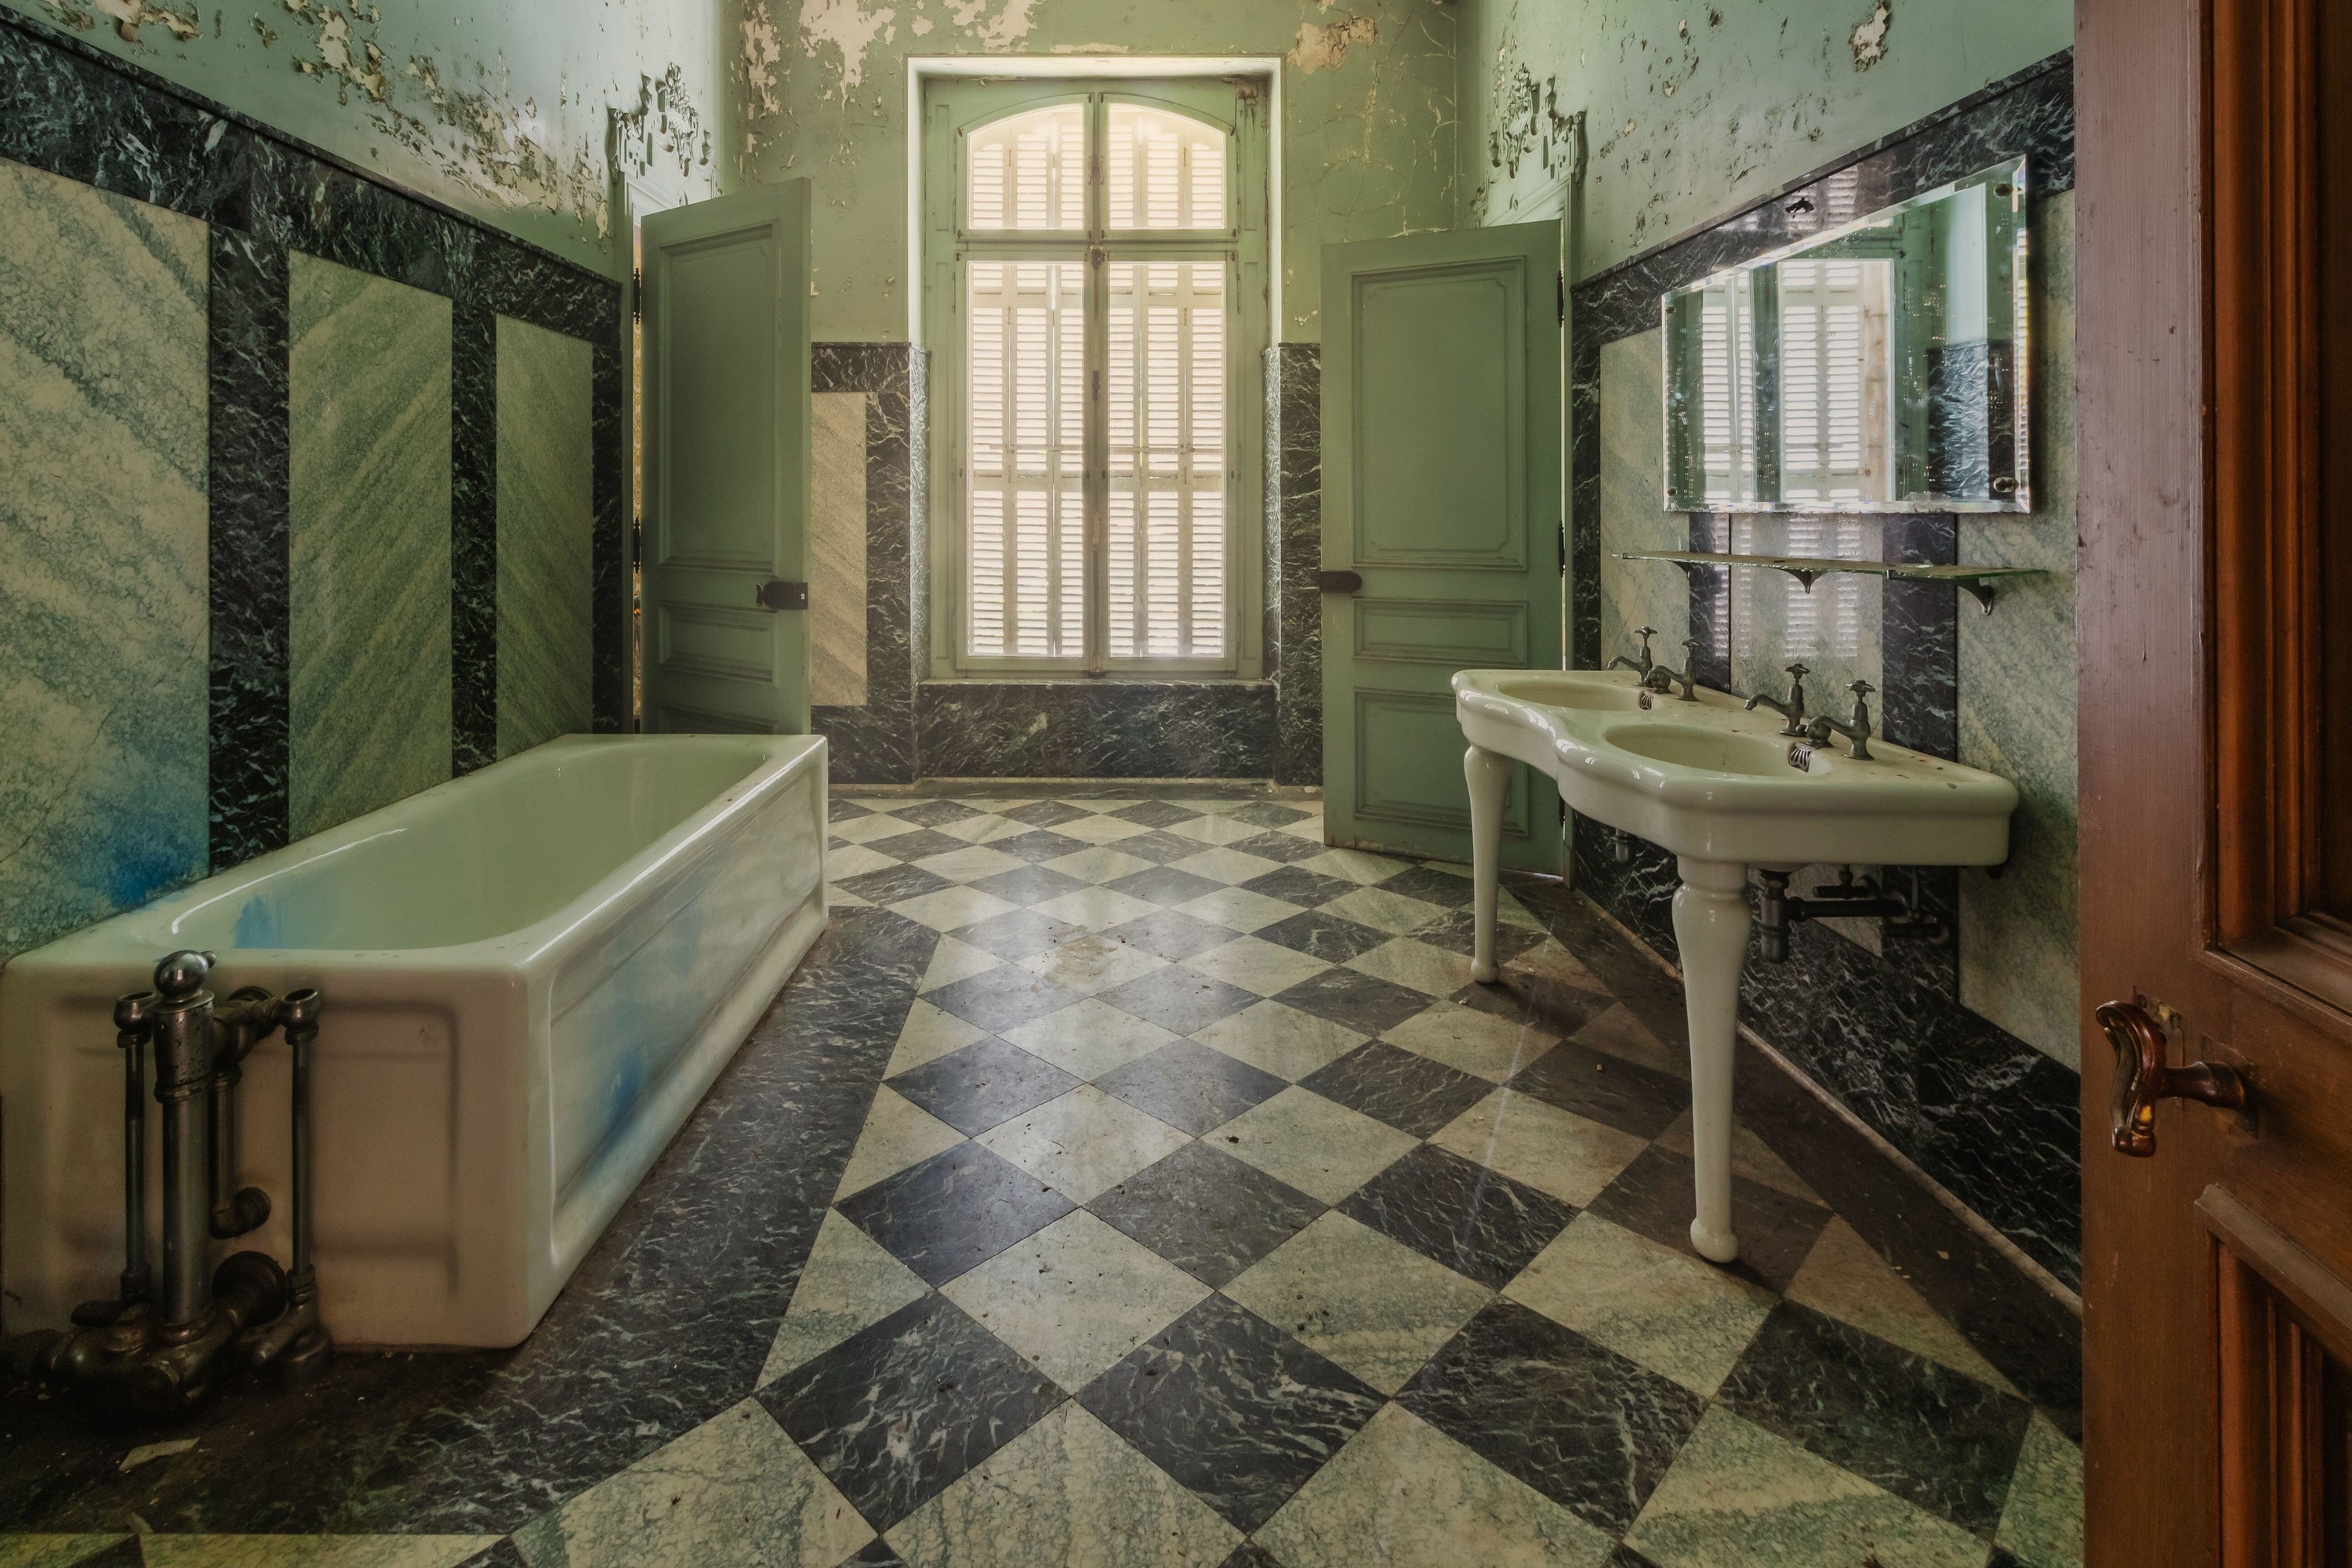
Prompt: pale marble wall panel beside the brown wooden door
<box><xmin>1959</xmin><ymin>191</ymin><xmax>2082</xmax><ymax>1065</ymax></box>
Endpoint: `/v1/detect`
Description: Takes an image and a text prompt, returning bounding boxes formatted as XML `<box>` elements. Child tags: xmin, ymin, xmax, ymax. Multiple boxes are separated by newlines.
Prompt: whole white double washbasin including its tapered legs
<box><xmin>1454</xmin><ymin>670</ymin><xmax>2018</xmax><ymax>1262</ymax></box>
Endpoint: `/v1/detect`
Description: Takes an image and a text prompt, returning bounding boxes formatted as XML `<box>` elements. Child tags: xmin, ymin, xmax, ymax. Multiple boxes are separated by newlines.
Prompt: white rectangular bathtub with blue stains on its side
<box><xmin>0</xmin><ymin>736</ymin><xmax>826</xmax><ymax>1347</ymax></box>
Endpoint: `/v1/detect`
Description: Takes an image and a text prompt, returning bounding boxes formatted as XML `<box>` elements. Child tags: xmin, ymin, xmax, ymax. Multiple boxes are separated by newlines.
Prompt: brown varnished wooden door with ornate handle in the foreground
<box><xmin>2077</xmin><ymin>0</ymin><xmax>2352</xmax><ymax>1568</ymax></box>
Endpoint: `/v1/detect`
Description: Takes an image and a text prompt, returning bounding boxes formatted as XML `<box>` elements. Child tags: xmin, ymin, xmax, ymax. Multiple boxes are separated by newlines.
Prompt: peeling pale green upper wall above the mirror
<box><xmin>1456</xmin><ymin>0</ymin><xmax>2074</xmax><ymax>278</ymax></box>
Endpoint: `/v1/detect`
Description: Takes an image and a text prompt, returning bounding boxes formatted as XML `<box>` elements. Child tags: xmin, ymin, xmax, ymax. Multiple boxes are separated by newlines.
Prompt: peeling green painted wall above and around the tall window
<box><xmin>724</xmin><ymin>0</ymin><xmax>1461</xmax><ymax>341</ymax></box>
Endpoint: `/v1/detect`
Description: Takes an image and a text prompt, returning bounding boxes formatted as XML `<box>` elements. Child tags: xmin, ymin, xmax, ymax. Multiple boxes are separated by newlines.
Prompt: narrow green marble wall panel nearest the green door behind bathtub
<box><xmin>499</xmin><ymin>315</ymin><xmax>595</xmax><ymax>757</ymax></box>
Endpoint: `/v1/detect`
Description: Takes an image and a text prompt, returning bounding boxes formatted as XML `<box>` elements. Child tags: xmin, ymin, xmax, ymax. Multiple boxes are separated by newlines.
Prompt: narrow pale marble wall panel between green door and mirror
<box><xmin>1599</xmin><ymin>332</ymin><xmax>1691</xmax><ymax>670</ymax></box>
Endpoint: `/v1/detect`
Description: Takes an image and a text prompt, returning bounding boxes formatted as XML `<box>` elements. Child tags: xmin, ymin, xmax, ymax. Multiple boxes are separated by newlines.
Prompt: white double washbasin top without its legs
<box><xmin>1454</xmin><ymin>670</ymin><xmax>2018</xmax><ymax>865</ymax></box>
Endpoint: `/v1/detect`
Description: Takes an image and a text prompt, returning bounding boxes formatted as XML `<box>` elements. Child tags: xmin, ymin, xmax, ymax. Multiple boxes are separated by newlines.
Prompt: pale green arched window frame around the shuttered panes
<box><xmin>920</xmin><ymin>73</ymin><xmax>1272</xmax><ymax>680</ymax></box>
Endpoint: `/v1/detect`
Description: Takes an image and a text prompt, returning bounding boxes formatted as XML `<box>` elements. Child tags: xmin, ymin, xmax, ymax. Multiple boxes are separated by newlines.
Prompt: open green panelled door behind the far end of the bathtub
<box><xmin>640</xmin><ymin>179</ymin><xmax>809</xmax><ymax>736</ymax></box>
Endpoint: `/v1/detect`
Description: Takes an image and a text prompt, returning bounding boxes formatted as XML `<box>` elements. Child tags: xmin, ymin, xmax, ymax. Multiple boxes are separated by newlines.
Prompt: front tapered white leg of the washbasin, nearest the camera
<box><xmin>1675</xmin><ymin>855</ymin><xmax>1748</xmax><ymax>1262</ymax></box>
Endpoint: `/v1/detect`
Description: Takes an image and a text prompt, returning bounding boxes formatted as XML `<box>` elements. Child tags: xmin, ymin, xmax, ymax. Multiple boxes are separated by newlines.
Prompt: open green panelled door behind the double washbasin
<box><xmin>1322</xmin><ymin>223</ymin><xmax>1566</xmax><ymax>872</ymax></box>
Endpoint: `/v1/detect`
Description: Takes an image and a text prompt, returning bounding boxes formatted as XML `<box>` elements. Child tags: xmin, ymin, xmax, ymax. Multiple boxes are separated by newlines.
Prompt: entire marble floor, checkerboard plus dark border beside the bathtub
<box><xmin>0</xmin><ymin>789</ymin><xmax>2082</xmax><ymax>1568</ymax></box>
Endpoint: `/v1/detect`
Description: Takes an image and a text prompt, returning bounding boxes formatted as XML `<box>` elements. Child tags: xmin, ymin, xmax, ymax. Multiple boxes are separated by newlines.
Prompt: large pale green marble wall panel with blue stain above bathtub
<box><xmin>0</xmin><ymin>160</ymin><xmax>209</xmax><ymax>956</ymax></box>
